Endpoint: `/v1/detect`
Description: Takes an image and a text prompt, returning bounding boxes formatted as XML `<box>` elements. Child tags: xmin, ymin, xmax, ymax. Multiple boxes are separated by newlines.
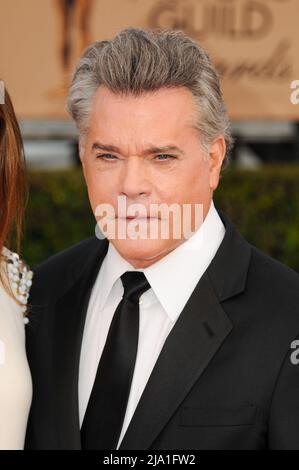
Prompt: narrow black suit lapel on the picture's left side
<box><xmin>53</xmin><ymin>240</ymin><xmax>108</xmax><ymax>449</ymax></box>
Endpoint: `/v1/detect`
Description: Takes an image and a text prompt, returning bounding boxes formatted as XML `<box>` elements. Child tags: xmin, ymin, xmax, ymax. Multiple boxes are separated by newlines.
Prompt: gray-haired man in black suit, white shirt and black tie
<box><xmin>26</xmin><ymin>29</ymin><xmax>299</xmax><ymax>450</ymax></box>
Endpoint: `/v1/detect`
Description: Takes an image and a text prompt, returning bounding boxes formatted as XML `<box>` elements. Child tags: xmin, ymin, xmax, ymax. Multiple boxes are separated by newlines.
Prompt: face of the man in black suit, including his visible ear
<box><xmin>80</xmin><ymin>86</ymin><xmax>225</xmax><ymax>268</ymax></box>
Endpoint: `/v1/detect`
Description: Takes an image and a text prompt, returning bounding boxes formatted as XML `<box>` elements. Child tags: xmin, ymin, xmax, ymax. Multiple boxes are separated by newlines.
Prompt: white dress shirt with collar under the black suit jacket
<box><xmin>79</xmin><ymin>201</ymin><xmax>225</xmax><ymax>447</ymax></box>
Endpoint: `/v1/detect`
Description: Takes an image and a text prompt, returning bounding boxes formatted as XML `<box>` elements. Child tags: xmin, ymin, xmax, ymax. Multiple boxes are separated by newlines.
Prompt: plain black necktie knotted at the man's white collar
<box><xmin>81</xmin><ymin>271</ymin><xmax>150</xmax><ymax>450</ymax></box>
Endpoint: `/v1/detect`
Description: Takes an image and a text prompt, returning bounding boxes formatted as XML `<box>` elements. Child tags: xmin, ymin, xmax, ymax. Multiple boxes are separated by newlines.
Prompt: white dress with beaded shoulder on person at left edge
<box><xmin>0</xmin><ymin>248</ymin><xmax>32</xmax><ymax>450</ymax></box>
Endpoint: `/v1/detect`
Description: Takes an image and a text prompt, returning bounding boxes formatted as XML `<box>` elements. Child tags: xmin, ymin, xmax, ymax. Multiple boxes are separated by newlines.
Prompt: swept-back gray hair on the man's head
<box><xmin>68</xmin><ymin>28</ymin><xmax>233</xmax><ymax>168</ymax></box>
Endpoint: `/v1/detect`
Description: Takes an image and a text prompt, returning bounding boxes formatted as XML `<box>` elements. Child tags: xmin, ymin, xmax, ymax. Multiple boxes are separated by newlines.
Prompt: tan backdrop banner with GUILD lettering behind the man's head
<box><xmin>0</xmin><ymin>0</ymin><xmax>299</xmax><ymax>120</ymax></box>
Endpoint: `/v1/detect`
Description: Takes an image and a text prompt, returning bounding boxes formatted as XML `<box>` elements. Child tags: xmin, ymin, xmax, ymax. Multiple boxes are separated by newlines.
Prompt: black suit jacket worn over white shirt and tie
<box><xmin>26</xmin><ymin>211</ymin><xmax>299</xmax><ymax>450</ymax></box>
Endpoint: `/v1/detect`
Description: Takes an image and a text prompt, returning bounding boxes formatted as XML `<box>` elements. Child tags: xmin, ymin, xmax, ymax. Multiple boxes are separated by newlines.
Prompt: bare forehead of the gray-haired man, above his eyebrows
<box><xmin>88</xmin><ymin>88</ymin><xmax>197</xmax><ymax>146</ymax></box>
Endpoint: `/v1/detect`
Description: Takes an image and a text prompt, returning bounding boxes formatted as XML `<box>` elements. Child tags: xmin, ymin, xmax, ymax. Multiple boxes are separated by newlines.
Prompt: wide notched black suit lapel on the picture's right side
<box><xmin>120</xmin><ymin>212</ymin><xmax>251</xmax><ymax>450</ymax></box>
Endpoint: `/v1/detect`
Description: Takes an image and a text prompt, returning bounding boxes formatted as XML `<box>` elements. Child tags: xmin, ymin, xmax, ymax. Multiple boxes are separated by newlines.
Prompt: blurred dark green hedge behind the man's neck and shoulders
<box><xmin>22</xmin><ymin>166</ymin><xmax>299</xmax><ymax>272</ymax></box>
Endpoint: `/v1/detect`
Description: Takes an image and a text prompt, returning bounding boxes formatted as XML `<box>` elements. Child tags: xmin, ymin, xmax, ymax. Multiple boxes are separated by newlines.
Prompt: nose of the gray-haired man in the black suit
<box><xmin>120</xmin><ymin>156</ymin><xmax>150</xmax><ymax>200</ymax></box>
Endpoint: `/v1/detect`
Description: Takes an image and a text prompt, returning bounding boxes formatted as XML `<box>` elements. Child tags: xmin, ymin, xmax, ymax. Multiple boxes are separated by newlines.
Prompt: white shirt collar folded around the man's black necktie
<box><xmin>100</xmin><ymin>201</ymin><xmax>225</xmax><ymax>322</ymax></box>
